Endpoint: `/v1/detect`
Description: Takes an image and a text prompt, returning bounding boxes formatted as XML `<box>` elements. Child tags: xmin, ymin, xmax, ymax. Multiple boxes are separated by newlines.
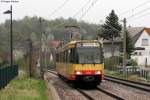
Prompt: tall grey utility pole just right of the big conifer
<box><xmin>123</xmin><ymin>18</ymin><xmax>127</xmax><ymax>68</ymax></box>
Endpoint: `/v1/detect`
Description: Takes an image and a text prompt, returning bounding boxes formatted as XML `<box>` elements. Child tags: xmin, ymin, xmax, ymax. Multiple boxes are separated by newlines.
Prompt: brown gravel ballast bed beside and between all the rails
<box><xmin>47</xmin><ymin>73</ymin><xmax>150</xmax><ymax>100</ymax></box>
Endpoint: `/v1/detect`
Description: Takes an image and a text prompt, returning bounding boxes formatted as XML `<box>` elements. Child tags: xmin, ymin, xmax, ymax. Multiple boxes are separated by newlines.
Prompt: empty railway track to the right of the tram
<box><xmin>105</xmin><ymin>75</ymin><xmax>150</xmax><ymax>92</ymax></box>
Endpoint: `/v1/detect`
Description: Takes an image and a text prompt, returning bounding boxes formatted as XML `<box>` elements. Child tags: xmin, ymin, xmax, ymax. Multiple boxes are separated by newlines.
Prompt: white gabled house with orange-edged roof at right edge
<box><xmin>128</xmin><ymin>27</ymin><xmax>150</xmax><ymax>66</ymax></box>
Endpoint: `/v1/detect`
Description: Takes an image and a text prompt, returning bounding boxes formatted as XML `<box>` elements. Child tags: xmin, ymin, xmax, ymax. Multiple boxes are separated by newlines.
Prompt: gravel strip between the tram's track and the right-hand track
<box><xmin>100</xmin><ymin>80</ymin><xmax>150</xmax><ymax>100</ymax></box>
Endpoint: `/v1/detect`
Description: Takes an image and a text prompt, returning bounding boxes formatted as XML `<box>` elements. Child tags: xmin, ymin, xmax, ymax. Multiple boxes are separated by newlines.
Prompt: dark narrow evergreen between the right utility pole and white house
<box><xmin>126</xmin><ymin>31</ymin><xmax>134</xmax><ymax>59</ymax></box>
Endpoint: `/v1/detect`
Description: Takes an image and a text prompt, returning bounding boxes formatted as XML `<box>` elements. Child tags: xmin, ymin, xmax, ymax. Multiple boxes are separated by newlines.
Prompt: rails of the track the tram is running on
<box><xmin>48</xmin><ymin>70</ymin><xmax>124</xmax><ymax>100</ymax></box>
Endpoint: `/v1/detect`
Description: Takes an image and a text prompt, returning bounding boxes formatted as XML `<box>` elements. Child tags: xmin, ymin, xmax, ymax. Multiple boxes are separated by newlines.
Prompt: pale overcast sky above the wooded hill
<box><xmin>0</xmin><ymin>0</ymin><xmax>150</xmax><ymax>27</ymax></box>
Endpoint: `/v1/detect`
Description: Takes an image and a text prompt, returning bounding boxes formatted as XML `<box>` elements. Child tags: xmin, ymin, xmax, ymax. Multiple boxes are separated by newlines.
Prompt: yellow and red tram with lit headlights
<box><xmin>56</xmin><ymin>40</ymin><xmax>104</xmax><ymax>85</ymax></box>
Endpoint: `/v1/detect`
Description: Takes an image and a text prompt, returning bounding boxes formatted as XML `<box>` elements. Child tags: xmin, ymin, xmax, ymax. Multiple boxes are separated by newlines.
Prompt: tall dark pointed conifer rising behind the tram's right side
<box><xmin>99</xmin><ymin>10</ymin><xmax>122</xmax><ymax>57</ymax></box>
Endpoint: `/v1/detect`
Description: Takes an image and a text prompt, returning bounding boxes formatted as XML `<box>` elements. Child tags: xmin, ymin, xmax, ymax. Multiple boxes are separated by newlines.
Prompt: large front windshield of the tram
<box><xmin>77</xmin><ymin>47</ymin><xmax>102</xmax><ymax>64</ymax></box>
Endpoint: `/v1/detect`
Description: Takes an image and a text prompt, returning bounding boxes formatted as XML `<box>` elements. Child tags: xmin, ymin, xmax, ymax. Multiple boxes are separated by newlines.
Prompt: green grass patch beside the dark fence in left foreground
<box><xmin>0</xmin><ymin>70</ymin><xmax>48</xmax><ymax>100</ymax></box>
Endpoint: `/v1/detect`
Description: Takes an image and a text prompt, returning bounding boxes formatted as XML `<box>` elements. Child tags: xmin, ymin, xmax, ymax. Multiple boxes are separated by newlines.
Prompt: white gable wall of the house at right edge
<box><xmin>131</xmin><ymin>31</ymin><xmax>150</xmax><ymax>66</ymax></box>
